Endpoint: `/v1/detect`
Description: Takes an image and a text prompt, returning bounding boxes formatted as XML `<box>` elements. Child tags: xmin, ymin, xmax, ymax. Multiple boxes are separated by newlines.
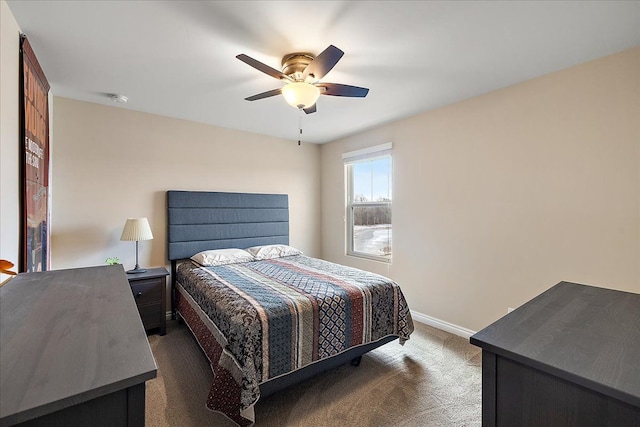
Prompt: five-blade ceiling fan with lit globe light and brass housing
<box><xmin>236</xmin><ymin>45</ymin><xmax>369</xmax><ymax>114</ymax></box>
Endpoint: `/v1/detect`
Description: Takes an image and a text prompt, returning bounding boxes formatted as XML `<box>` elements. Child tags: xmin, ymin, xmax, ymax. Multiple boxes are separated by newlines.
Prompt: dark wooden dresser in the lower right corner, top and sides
<box><xmin>470</xmin><ymin>282</ymin><xmax>640</xmax><ymax>427</ymax></box>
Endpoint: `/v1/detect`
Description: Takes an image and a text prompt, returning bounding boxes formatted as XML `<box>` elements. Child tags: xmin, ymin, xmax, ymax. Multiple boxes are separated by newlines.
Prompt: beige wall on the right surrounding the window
<box><xmin>321</xmin><ymin>48</ymin><xmax>640</xmax><ymax>330</ymax></box>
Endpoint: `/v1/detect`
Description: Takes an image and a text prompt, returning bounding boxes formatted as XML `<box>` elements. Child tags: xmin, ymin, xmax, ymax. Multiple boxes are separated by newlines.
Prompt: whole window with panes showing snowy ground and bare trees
<box><xmin>343</xmin><ymin>143</ymin><xmax>393</xmax><ymax>262</ymax></box>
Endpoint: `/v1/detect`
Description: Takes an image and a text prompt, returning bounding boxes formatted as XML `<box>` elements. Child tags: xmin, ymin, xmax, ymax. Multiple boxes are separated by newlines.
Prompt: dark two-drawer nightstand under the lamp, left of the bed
<box><xmin>127</xmin><ymin>267</ymin><xmax>169</xmax><ymax>335</ymax></box>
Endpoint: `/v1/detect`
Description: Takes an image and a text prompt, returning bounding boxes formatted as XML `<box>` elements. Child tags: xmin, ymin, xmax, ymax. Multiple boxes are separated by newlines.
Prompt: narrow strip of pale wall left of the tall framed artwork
<box><xmin>0</xmin><ymin>0</ymin><xmax>20</xmax><ymax>283</ymax></box>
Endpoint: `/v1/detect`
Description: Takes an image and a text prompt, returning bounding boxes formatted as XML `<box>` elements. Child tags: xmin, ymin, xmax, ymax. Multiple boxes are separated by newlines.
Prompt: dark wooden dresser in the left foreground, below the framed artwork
<box><xmin>0</xmin><ymin>265</ymin><xmax>157</xmax><ymax>427</ymax></box>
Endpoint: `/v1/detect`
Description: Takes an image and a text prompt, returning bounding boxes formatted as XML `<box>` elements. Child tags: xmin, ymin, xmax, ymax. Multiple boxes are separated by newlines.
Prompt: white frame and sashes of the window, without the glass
<box><xmin>342</xmin><ymin>142</ymin><xmax>393</xmax><ymax>263</ymax></box>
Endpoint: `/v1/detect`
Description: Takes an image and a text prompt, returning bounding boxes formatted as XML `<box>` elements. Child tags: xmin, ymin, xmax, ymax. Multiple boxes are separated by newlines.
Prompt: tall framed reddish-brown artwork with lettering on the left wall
<box><xmin>19</xmin><ymin>35</ymin><xmax>50</xmax><ymax>272</ymax></box>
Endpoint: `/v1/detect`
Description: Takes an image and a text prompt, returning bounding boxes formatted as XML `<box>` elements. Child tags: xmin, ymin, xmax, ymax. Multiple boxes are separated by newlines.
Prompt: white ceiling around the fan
<box><xmin>8</xmin><ymin>0</ymin><xmax>640</xmax><ymax>143</ymax></box>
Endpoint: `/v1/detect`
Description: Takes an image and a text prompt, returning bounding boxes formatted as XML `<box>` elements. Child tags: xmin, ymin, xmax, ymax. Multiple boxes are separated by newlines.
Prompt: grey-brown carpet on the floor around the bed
<box><xmin>146</xmin><ymin>321</ymin><xmax>481</xmax><ymax>427</ymax></box>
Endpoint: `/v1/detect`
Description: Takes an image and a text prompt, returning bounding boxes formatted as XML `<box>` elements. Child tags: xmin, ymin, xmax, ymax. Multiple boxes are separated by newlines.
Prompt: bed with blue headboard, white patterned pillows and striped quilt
<box><xmin>167</xmin><ymin>191</ymin><xmax>413</xmax><ymax>426</ymax></box>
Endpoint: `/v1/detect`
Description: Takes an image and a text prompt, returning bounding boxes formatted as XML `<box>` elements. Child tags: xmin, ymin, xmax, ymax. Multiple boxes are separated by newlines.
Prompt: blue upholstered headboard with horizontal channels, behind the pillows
<box><xmin>167</xmin><ymin>190</ymin><xmax>289</xmax><ymax>261</ymax></box>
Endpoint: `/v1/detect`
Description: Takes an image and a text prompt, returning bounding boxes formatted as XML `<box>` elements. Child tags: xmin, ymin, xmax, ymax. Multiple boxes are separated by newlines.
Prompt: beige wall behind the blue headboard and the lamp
<box><xmin>51</xmin><ymin>97</ymin><xmax>320</xmax><ymax>269</ymax></box>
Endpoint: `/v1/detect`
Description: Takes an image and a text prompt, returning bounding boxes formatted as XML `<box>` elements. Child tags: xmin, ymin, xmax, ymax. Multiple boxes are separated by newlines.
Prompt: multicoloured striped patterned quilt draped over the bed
<box><xmin>176</xmin><ymin>255</ymin><xmax>413</xmax><ymax>426</ymax></box>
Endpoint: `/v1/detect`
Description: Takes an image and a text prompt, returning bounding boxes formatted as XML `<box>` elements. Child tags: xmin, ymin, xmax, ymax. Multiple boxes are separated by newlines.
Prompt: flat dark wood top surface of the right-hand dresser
<box><xmin>470</xmin><ymin>282</ymin><xmax>640</xmax><ymax>406</ymax></box>
